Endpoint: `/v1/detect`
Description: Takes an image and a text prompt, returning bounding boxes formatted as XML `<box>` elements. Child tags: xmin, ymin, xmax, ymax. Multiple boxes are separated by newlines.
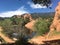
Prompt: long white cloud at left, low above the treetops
<box><xmin>0</xmin><ymin>6</ymin><xmax>28</xmax><ymax>17</ymax></box>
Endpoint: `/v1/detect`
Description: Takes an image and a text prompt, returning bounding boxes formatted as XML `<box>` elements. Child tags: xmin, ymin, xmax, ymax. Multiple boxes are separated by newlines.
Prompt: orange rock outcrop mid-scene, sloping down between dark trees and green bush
<box><xmin>24</xmin><ymin>14</ymin><xmax>35</xmax><ymax>30</ymax></box>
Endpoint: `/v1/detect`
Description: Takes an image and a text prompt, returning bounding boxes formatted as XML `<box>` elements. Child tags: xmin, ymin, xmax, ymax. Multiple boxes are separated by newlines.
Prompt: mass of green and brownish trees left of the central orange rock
<box><xmin>0</xmin><ymin>17</ymin><xmax>29</xmax><ymax>38</ymax></box>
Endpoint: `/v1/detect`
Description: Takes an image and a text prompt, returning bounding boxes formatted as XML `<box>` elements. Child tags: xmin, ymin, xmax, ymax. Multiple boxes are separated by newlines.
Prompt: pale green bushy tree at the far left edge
<box><xmin>0</xmin><ymin>19</ymin><xmax>13</xmax><ymax>35</ymax></box>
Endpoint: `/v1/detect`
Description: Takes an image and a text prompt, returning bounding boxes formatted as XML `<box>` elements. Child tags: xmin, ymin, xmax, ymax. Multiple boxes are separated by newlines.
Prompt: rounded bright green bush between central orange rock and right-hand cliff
<box><xmin>34</xmin><ymin>18</ymin><xmax>50</xmax><ymax>35</ymax></box>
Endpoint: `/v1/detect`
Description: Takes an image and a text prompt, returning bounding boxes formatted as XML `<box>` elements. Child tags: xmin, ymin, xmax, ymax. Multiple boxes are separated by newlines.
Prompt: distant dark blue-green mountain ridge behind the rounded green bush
<box><xmin>31</xmin><ymin>12</ymin><xmax>55</xmax><ymax>19</ymax></box>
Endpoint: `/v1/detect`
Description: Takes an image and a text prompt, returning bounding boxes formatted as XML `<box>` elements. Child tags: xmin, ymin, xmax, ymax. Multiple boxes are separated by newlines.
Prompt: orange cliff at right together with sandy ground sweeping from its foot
<box><xmin>29</xmin><ymin>2</ymin><xmax>60</xmax><ymax>45</ymax></box>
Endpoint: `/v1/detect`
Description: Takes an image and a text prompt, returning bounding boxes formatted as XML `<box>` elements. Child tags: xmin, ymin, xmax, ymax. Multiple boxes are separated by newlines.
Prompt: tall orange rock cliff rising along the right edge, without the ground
<box><xmin>50</xmin><ymin>2</ymin><xmax>60</xmax><ymax>31</ymax></box>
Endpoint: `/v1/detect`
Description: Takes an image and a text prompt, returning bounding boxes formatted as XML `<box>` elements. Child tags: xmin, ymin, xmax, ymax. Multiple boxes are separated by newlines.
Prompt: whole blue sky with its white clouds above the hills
<box><xmin>0</xmin><ymin>0</ymin><xmax>60</xmax><ymax>17</ymax></box>
